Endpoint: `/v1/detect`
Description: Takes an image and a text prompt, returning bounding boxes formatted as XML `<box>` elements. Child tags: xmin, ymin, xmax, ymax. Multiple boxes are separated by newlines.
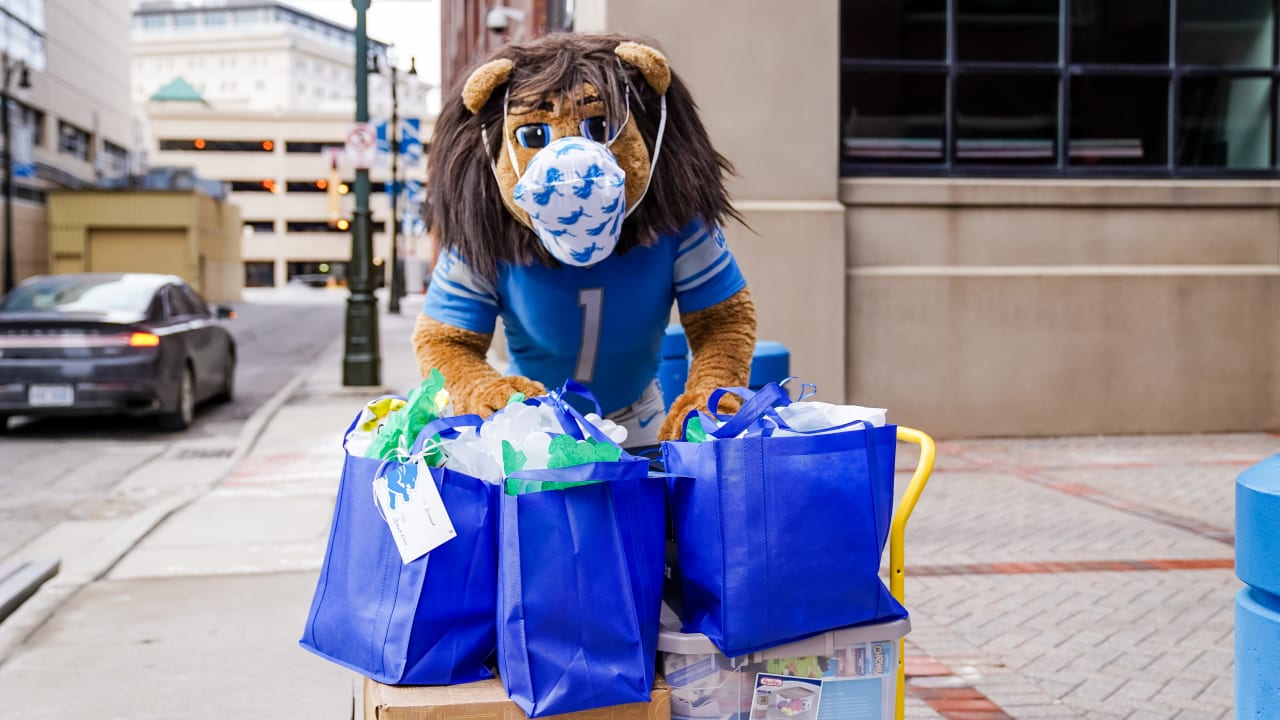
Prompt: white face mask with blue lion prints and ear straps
<box><xmin>481</xmin><ymin>83</ymin><xmax>667</xmax><ymax>268</ymax></box>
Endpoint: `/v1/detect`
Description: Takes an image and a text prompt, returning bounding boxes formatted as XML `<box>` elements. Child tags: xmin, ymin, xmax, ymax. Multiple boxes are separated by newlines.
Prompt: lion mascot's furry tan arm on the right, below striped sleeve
<box><xmin>658</xmin><ymin>288</ymin><xmax>755</xmax><ymax>439</ymax></box>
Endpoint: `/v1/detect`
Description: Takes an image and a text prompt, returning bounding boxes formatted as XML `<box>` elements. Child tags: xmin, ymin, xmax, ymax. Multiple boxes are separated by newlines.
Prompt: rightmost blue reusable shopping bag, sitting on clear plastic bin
<box><xmin>662</xmin><ymin>383</ymin><xmax>906</xmax><ymax>657</ymax></box>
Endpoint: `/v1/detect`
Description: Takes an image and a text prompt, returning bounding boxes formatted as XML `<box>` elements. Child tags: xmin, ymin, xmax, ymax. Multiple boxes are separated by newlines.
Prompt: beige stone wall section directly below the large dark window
<box><xmin>841</xmin><ymin>179</ymin><xmax>1280</xmax><ymax>437</ymax></box>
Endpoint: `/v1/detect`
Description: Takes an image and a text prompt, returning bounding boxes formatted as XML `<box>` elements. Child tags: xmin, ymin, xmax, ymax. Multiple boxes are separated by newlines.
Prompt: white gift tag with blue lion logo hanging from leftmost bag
<box><xmin>374</xmin><ymin>462</ymin><xmax>457</xmax><ymax>565</ymax></box>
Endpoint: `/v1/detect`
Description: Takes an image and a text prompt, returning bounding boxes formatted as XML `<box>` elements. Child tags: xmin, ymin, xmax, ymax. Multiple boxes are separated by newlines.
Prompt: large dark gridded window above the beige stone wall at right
<box><xmin>840</xmin><ymin>0</ymin><xmax>1280</xmax><ymax>177</ymax></box>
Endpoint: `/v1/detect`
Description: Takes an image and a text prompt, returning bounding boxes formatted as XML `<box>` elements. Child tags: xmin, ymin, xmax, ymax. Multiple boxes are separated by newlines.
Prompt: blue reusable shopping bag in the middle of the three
<box><xmin>498</xmin><ymin>389</ymin><xmax>666</xmax><ymax>717</ymax></box>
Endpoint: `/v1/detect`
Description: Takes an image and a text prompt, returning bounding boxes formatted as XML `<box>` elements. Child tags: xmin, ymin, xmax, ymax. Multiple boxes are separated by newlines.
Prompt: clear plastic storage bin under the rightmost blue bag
<box><xmin>658</xmin><ymin>606</ymin><xmax>911</xmax><ymax>720</ymax></box>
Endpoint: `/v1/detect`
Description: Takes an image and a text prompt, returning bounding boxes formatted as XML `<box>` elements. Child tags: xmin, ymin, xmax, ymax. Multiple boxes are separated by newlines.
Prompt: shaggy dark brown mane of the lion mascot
<box><xmin>424</xmin><ymin>33</ymin><xmax>742</xmax><ymax>278</ymax></box>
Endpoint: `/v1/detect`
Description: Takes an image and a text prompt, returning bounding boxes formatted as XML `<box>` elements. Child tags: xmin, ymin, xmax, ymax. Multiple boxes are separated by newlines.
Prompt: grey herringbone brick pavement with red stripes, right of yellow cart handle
<box><xmin>899</xmin><ymin>433</ymin><xmax>1280</xmax><ymax>720</ymax></box>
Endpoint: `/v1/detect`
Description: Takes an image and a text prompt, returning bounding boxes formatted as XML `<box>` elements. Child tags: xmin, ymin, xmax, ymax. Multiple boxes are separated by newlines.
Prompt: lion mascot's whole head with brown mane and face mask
<box><xmin>426</xmin><ymin>33</ymin><xmax>741</xmax><ymax>278</ymax></box>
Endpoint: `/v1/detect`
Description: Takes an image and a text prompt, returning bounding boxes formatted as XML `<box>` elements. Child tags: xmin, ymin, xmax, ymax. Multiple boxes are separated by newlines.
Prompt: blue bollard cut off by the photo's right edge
<box><xmin>1235</xmin><ymin>455</ymin><xmax>1280</xmax><ymax>720</ymax></box>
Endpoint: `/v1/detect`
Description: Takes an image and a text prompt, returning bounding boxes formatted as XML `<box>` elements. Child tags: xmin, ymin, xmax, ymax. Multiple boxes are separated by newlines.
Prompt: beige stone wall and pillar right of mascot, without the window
<box><xmin>576</xmin><ymin>0</ymin><xmax>1280</xmax><ymax>437</ymax></box>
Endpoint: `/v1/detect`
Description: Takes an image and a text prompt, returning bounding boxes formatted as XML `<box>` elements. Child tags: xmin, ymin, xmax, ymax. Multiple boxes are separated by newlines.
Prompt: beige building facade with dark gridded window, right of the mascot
<box><xmin>552</xmin><ymin>0</ymin><xmax>1280</xmax><ymax>437</ymax></box>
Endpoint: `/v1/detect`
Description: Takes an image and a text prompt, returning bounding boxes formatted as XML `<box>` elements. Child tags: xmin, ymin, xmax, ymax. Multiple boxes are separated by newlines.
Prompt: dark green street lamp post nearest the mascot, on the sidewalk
<box><xmin>342</xmin><ymin>0</ymin><xmax>381</xmax><ymax>386</ymax></box>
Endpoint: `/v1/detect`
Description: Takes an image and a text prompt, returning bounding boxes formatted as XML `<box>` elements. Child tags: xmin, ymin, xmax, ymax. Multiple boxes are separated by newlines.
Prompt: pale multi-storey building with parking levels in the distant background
<box><xmin>133</xmin><ymin>0</ymin><xmax>431</xmax><ymax>287</ymax></box>
